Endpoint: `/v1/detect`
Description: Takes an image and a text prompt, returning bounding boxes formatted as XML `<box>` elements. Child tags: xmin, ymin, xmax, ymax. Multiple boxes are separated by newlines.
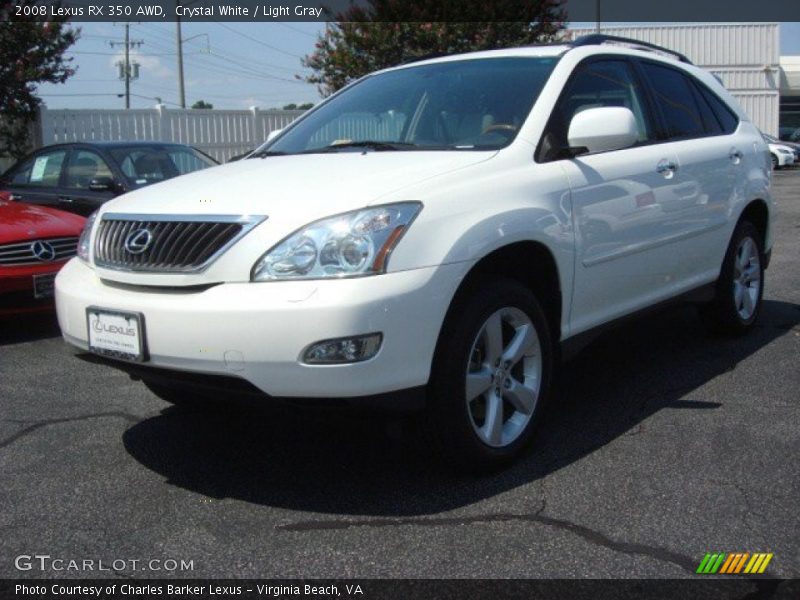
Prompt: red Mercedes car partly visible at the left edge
<box><xmin>0</xmin><ymin>192</ymin><xmax>86</xmax><ymax>318</ymax></box>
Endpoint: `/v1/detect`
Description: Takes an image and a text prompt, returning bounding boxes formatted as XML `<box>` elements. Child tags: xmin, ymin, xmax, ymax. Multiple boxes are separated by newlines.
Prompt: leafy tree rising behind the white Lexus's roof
<box><xmin>303</xmin><ymin>0</ymin><xmax>566</xmax><ymax>96</ymax></box>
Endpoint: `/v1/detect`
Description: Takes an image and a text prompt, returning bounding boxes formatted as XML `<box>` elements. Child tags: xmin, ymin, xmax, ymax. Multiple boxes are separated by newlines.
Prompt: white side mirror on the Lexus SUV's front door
<box><xmin>567</xmin><ymin>106</ymin><xmax>639</xmax><ymax>155</ymax></box>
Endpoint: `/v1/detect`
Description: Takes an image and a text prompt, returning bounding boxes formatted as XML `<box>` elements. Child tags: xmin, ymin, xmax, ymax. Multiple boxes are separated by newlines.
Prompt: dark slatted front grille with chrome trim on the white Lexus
<box><xmin>93</xmin><ymin>213</ymin><xmax>267</xmax><ymax>273</ymax></box>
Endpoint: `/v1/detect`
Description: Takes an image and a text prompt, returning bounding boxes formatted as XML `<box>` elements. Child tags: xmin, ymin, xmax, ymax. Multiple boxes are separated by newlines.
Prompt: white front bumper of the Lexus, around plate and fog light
<box><xmin>56</xmin><ymin>259</ymin><xmax>468</xmax><ymax>398</ymax></box>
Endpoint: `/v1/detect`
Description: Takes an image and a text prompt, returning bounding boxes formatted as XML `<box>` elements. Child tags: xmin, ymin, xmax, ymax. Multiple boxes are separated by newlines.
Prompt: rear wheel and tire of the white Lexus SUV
<box><xmin>701</xmin><ymin>221</ymin><xmax>764</xmax><ymax>335</ymax></box>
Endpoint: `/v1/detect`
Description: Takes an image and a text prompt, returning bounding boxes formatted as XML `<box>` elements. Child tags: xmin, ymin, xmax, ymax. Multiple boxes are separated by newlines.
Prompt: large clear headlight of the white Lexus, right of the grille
<box><xmin>252</xmin><ymin>202</ymin><xmax>422</xmax><ymax>281</ymax></box>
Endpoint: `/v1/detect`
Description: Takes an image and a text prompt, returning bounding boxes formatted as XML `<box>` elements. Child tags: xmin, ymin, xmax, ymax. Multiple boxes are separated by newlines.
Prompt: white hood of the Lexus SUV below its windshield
<box><xmin>103</xmin><ymin>151</ymin><xmax>496</xmax><ymax>222</ymax></box>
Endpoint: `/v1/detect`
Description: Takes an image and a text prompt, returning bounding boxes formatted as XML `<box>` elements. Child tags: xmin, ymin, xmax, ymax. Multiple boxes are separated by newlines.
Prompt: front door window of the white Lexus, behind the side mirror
<box><xmin>537</xmin><ymin>60</ymin><xmax>654</xmax><ymax>161</ymax></box>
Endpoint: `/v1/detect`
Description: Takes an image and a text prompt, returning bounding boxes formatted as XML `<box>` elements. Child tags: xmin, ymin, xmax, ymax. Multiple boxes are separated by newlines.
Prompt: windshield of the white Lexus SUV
<box><xmin>260</xmin><ymin>57</ymin><xmax>558</xmax><ymax>157</ymax></box>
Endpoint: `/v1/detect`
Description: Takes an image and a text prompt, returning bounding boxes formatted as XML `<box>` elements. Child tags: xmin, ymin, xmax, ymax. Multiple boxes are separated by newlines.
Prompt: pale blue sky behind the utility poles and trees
<box><xmin>34</xmin><ymin>22</ymin><xmax>800</xmax><ymax>109</ymax></box>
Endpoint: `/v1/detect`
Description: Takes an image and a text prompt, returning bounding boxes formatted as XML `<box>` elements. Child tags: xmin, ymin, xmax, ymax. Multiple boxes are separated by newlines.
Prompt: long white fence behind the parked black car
<box><xmin>35</xmin><ymin>105</ymin><xmax>303</xmax><ymax>162</ymax></box>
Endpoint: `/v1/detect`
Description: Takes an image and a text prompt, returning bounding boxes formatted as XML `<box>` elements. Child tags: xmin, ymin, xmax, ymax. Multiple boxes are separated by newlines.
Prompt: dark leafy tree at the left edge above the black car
<box><xmin>0</xmin><ymin>0</ymin><xmax>80</xmax><ymax>158</ymax></box>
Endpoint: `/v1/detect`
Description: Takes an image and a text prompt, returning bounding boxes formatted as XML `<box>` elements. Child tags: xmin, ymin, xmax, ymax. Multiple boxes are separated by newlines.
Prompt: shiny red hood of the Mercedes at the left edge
<box><xmin>0</xmin><ymin>200</ymin><xmax>86</xmax><ymax>244</ymax></box>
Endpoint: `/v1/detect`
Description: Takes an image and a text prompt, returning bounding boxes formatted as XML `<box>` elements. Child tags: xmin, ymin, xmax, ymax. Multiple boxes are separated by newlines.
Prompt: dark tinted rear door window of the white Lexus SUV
<box><xmin>641</xmin><ymin>62</ymin><xmax>706</xmax><ymax>139</ymax></box>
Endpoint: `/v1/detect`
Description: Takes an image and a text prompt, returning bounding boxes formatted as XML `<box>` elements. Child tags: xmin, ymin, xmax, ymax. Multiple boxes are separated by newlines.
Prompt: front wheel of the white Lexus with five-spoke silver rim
<box><xmin>425</xmin><ymin>279</ymin><xmax>554</xmax><ymax>472</ymax></box>
